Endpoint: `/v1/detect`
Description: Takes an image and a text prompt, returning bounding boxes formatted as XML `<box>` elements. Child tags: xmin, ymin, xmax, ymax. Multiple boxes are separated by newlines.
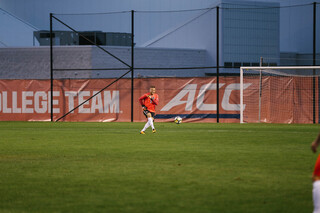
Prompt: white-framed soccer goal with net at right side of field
<box><xmin>240</xmin><ymin>66</ymin><xmax>320</xmax><ymax>123</ymax></box>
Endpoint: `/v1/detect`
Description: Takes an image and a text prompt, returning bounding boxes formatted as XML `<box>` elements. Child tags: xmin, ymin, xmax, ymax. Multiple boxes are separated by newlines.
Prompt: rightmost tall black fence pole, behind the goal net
<box><xmin>312</xmin><ymin>2</ymin><xmax>317</xmax><ymax>123</ymax></box>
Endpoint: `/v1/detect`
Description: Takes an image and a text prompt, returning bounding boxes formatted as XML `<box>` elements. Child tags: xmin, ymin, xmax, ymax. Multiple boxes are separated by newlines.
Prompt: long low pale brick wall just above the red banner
<box><xmin>0</xmin><ymin>46</ymin><xmax>207</xmax><ymax>79</ymax></box>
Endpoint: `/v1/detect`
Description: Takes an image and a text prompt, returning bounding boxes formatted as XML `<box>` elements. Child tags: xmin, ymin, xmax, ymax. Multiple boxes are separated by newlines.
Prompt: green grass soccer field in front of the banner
<box><xmin>0</xmin><ymin>122</ymin><xmax>319</xmax><ymax>213</ymax></box>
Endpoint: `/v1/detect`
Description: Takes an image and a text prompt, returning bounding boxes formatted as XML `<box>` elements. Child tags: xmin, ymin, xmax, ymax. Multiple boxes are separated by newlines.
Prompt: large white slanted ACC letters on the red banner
<box><xmin>161</xmin><ymin>83</ymin><xmax>251</xmax><ymax>111</ymax></box>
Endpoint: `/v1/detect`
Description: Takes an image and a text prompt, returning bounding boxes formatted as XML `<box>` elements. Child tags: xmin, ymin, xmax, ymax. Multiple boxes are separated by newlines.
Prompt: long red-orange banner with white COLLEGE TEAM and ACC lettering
<box><xmin>0</xmin><ymin>76</ymin><xmax>312</xmax><ymax>123</ymax></box>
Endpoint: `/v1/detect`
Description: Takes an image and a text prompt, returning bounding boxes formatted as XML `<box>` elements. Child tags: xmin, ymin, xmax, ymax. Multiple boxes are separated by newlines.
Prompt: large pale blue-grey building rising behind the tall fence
<box><xmin>0</xmin><ymin>0</ymin><xmax>320</xmax><ymax>78</ymax></box>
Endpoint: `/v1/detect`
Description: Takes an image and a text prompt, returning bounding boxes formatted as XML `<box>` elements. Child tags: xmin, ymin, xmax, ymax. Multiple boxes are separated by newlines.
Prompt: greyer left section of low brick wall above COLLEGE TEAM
<box><xmin>0</xmin><ymin>47</ymin><xmax>91</xmax><ymax>79</ymax></box>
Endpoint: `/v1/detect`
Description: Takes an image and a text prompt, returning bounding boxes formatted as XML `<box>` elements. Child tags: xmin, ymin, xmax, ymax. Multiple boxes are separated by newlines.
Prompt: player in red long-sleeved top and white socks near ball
<box><xmin>139</xmin><ymin>86</ymin><xmax>159</xmax><ymax>135</ymax></box>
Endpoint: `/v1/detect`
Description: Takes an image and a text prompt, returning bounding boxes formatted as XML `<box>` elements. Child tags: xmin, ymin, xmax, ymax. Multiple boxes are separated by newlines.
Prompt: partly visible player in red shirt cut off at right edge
<box><xmin>311</xmin><ymin>133</ymin><xmax>320</xmax><ymax>213</ymax></box>
